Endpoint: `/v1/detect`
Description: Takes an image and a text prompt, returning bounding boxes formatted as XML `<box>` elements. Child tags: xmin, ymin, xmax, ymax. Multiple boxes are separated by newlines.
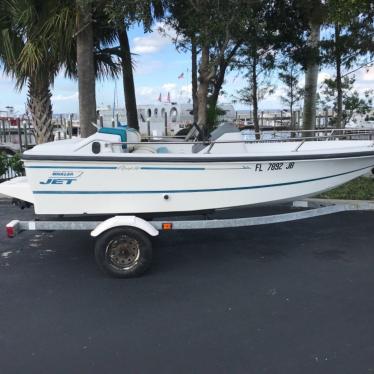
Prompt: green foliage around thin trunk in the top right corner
<box><xmin>320</xmin><ymin>0</ymin><xmax>374</xmax><ymax>128</ymax></box>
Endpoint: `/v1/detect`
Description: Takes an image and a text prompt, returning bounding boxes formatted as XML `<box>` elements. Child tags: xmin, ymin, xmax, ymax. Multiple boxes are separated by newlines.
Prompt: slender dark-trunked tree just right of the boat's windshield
<box><xmin>231</xmin><ymin>0</ymin><xmax>306</xmax><ymax>137</ymax></box>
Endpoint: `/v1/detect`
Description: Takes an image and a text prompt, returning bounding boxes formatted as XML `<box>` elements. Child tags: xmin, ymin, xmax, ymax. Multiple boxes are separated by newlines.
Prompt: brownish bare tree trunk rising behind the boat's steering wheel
<box><xmin>197</xmin><ymin>46</ymin><xmax>210</xmax><ymax>135</ymax></box>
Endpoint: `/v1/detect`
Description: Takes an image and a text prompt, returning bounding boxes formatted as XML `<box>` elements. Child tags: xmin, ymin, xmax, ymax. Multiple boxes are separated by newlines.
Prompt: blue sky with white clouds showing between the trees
<box><xmin>0</xmin><ymin>24</ymin><xmax>374</xmax><ymax>114</ymax></box>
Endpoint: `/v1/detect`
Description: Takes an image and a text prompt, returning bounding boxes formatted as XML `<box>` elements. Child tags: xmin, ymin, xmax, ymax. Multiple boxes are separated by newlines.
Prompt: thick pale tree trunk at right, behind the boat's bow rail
<box><xmin>303</xmin><ymin>23</ymin><xmax>320</xmax><ymax>130</ymax></box>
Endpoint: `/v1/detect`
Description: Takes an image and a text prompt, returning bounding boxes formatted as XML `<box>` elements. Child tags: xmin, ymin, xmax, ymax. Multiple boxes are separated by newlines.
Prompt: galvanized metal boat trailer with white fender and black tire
<box><xmin>6</xmin><ymin>199</ymin><xmax>374</xmax><ymax>278</ymax></box>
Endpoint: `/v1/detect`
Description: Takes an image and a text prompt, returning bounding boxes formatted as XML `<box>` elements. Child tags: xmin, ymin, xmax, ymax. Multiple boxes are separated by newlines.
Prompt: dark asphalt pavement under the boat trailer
<box><xmin>0</xmin><ymin>202</ymin><xmax>374</xmax><ymax>374</ymax></box>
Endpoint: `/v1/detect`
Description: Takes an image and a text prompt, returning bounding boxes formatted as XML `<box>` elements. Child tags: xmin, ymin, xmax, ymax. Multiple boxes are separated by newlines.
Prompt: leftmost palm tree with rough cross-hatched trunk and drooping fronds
<box><xmin>0</xmin><ymin>0</ymin><xmax>118</xmax><ymax>143</ymax></box>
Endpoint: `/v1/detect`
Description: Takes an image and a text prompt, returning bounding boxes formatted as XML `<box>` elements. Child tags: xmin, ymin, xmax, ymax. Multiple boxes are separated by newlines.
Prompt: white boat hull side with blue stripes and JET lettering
<box><xmin>19</xmin><ymin>155</ymin><xmax>374</xmax><ymax>215</ymax></box>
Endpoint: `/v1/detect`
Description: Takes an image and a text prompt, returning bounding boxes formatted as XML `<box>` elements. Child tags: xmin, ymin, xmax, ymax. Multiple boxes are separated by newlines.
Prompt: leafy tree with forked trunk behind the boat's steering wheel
<box><xmin>167</xmin><ymin>0</ymin><xmax>248</xmax><ymax>132</ymax></box>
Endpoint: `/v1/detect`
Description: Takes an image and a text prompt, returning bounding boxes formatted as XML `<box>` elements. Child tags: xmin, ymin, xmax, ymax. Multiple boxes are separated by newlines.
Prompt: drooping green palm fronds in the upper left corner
<box><xmin>0</xmin><ymin>0</ymin><xmax>119</xmax><ymax>88</ymax></box>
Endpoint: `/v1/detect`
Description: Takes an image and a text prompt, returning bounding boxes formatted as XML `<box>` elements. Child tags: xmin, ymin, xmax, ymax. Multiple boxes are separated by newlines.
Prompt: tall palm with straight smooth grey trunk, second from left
<box><xmin>45</xmin><ymin>0</ymin><xmax>120</xmax><ymax>137</ymax></box>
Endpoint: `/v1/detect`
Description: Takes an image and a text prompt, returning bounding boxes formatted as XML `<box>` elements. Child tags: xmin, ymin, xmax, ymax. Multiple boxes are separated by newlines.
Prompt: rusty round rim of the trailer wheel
<box><xmin>105</xmin><ymin>235</ymin><xmax>140</xmax><ymax>270</ymax></box>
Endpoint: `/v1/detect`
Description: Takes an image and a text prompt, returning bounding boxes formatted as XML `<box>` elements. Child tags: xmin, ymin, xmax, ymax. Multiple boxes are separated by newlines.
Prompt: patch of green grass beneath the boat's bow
<box><xmin>318</xmin><ymin>177</ymin><xmax>374</xmax><ymax>200</ymax></box>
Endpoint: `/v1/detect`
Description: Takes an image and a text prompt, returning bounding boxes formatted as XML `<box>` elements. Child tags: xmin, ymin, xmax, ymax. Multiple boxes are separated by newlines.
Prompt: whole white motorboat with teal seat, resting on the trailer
<box><xmin>0</xmin><ymin>125</ymin><xmax>374</xmax><ymax>215</ymax></box>
